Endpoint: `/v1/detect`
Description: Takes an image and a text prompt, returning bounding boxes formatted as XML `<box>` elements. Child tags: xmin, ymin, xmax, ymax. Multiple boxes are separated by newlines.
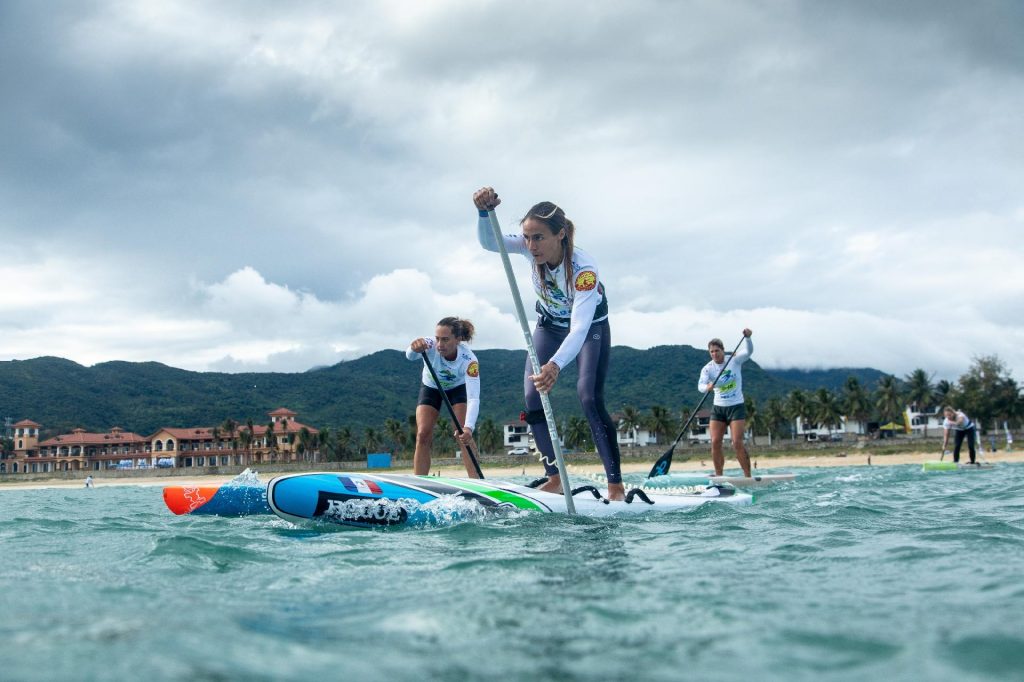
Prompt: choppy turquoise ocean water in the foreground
<box><xmin>0</xmin><ymin>464</ymin><xmax>1024</xmax><ymax>682</ymax></box>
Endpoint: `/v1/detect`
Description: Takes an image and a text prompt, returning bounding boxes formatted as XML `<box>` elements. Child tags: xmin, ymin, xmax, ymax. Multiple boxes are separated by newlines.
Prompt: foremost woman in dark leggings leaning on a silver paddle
<box><xmin>473</xmin><ymin>187</ymin><xmax>626</xmax><ymax>500</ymax></box>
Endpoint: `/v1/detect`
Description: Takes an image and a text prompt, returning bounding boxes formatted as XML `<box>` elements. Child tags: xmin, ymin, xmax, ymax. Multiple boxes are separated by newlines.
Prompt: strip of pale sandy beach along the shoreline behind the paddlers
<box><xmin>0</xmin><ymin>451</ymin><xmax>1024</xmax><ymax>491</ymax></box>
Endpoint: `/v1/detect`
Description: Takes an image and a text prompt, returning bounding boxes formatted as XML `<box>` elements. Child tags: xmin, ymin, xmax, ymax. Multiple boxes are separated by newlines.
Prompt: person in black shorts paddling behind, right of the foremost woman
<box><xmin>697</xmin><ymin>329</ymin><xmax>754</xmax><ymax>478</ymax></box>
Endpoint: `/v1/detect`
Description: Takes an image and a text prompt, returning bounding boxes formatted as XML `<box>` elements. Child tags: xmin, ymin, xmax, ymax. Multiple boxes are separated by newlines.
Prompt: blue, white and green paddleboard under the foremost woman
<box><xmin>267</xmin><ymin>472</ymin><xmax>754</xmax><ymax>527</ymax></box>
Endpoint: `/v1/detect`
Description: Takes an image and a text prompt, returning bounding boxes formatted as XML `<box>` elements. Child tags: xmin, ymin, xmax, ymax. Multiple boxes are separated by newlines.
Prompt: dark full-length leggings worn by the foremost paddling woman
<box><xmin>523</xmin><ymin>319</ymin><xmax>623</xmax><ymax>483</ymax></box>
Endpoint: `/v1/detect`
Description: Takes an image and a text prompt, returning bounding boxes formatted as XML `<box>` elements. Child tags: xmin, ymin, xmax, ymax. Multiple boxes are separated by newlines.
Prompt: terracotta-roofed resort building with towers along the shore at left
<box><xmin>0</xmin><ymin>408</ymin><xmax>319</xmax><ymax>474</ymax></box>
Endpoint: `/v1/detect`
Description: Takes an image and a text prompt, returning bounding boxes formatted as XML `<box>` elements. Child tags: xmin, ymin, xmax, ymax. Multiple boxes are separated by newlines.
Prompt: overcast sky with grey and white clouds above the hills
<box><xmin>0</xmin><ymin>0</ymin><xmax>1024</xmax><ymax>381</ymax></box>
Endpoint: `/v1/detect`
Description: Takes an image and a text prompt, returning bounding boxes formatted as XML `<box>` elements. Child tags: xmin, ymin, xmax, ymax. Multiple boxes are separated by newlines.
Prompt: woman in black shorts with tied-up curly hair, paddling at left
<box><xmin>406</xmin><ymin>317</ymin><xmax>480</xmax><ymax>478</ymax></box>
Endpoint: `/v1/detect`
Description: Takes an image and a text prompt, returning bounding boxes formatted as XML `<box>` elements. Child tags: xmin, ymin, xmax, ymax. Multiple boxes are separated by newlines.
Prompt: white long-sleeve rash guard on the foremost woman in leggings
<box><xmin>476</xmin><ymin>215</ymin><xmax>608</xmax><ymax>370</ymax></box>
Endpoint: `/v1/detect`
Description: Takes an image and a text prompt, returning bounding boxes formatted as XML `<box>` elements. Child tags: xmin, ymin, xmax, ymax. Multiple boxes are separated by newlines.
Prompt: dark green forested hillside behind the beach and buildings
<box><xmin>0</xmin><ymin>346</ymin><xmax>882</xmax><ymax>435</ymax></box>
